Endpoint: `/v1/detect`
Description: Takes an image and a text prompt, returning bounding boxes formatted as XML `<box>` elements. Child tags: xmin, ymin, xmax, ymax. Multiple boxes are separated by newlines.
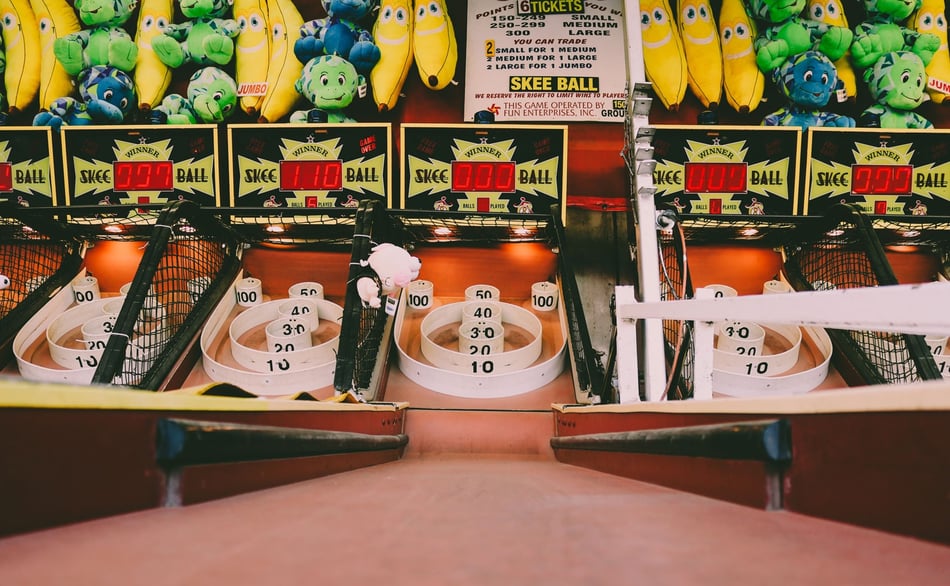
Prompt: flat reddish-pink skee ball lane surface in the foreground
<box><xmin>0</xmin><ymin>452</ymin><xmax>950</xmax><ymax>586</ymax></box>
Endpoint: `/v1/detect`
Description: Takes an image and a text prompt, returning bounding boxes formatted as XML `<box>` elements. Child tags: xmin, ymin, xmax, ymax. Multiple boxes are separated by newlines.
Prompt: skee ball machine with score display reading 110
<box><xmin>174</xmin><ymin>124</ymin><xmax>392</xmax><ymax>400</ymax></box>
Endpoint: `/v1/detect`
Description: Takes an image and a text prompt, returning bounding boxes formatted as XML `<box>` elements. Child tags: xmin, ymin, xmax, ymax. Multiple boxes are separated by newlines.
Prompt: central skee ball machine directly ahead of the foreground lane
<box><xmin>386</xmin><ymin>124</ymin><xmax>609</xmax><ymax>409</ymax></box>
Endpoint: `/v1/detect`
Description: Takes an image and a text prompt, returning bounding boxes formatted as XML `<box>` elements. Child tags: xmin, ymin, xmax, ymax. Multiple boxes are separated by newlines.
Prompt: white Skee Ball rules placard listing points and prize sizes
<box><xmin>465</xmin><ymin>0</ymin><xmax>627</xmax><ymax>122</ymax></box>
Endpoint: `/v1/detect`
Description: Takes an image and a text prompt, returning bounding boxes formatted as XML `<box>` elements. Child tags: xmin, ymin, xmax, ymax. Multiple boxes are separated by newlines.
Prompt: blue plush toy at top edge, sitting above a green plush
<box><xmin>294</xmin><ymin>0</ymin><xmax>380</xmax><ymax>74</ymax></box>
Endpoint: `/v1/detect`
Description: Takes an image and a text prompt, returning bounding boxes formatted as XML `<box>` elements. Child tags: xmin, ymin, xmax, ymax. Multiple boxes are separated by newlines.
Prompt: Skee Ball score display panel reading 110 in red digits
<box><xmin>228</xmin><ymin>123</ymin><xmax>392</xmax><ymax>208</ymax></box>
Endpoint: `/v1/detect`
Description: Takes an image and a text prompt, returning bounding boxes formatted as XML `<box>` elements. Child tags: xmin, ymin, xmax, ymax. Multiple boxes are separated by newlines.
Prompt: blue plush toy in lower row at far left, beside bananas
<box><xmin>33</xmin><ymin>65</ymin><xmax>135</xmax><ymax>129</ymax></box>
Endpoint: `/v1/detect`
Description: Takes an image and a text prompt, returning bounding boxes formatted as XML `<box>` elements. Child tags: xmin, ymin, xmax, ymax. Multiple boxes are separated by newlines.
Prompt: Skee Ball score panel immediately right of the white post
<box><xmin>651</xmin><ymin>126</ymin><xmax>802</xmax><ymax>216</ymax></box>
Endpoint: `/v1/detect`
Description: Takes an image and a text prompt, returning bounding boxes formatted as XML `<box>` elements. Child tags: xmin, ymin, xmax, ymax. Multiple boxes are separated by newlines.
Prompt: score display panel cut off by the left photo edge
<box><xmin>0</xmin><ymin>126</ymin><xmax>59</xmax><ymax>207</ymax></box>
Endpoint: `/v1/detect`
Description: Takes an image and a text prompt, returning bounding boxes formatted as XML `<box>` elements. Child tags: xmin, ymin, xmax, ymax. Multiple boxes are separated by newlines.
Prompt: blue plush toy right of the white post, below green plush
<box><xmin>762</xmin><ymin>51</ymin><xmax>855</xmax><ymax>128</ymax></box>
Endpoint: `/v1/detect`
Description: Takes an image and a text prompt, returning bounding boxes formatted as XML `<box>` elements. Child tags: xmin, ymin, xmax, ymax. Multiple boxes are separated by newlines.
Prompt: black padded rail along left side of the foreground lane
<box><xmin>157</xmin><ymin>418</ymin><xmax>409</xmax><ymax>466</ymax></box>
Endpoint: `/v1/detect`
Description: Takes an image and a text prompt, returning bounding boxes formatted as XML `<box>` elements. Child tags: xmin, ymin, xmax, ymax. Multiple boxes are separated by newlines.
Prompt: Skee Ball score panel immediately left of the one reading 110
<box><xmin>60</xmin><ymin>124</ymin><xmax>222</xmax><ymax>206</ymax></box>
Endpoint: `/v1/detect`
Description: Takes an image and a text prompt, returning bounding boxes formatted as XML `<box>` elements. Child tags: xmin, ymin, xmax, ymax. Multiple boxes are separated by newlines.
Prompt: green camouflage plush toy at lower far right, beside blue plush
<box><xmin>860</xmin><ymin>51</ymin><xmax>933</xmax><ymax>128</ymax></box>
